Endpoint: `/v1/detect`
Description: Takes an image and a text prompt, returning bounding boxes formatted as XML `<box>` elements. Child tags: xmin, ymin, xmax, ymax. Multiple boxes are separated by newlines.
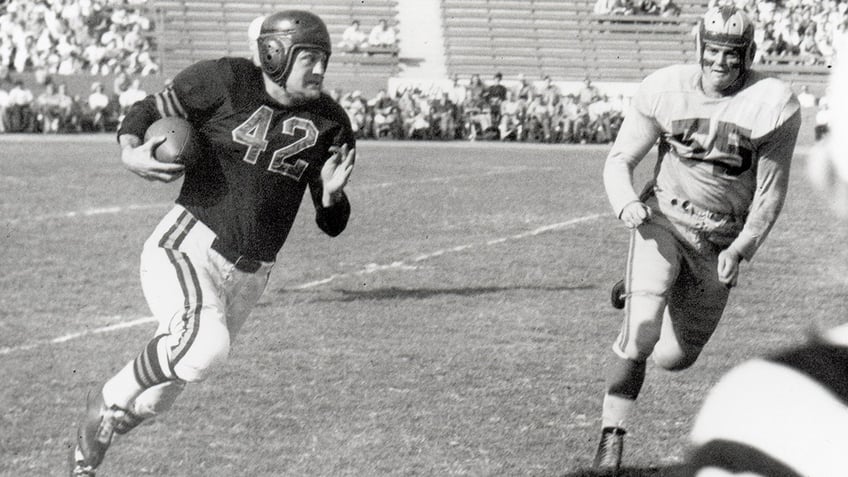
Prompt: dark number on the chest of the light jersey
<box><xmin>672</xmin><ymin>118</ymin><xmax>754</xmax><ymax>176</ymax></box>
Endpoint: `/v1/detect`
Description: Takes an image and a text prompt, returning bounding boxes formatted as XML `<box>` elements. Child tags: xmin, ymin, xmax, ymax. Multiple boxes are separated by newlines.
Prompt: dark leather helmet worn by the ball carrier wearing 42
<box><xmin>256</xmin><ymin>10</ymin><xmax>332</xmax><ymax>87</ymax></box>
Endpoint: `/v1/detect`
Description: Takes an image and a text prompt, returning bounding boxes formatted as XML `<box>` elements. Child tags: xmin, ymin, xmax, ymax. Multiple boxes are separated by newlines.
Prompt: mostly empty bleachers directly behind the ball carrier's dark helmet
<box><xmin>153</xmin><ymin>0</ymin><xmax>398</xmax><ymax>95</ymax></box>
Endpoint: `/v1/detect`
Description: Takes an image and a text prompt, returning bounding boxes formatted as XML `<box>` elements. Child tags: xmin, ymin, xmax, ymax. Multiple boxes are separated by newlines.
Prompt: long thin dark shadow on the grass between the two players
<box><xmin>277</xmin><ymin>285</ymin><xmax>597</xmax><ymax>302</ymax></box>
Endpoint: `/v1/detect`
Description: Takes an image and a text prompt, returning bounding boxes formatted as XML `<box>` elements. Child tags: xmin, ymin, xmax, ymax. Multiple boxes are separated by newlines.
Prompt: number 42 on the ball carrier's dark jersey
<box><xmin>233</xmin><ymin>106</ymin><xmax>318</xmax><ymax>181</ymax></box>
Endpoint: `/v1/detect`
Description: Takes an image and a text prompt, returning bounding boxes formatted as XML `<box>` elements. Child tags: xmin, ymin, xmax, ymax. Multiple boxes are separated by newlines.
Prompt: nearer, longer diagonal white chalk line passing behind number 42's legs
<box><xmin>0</xmin><ymin>213</ymin><xmax>606</xmax><ymax>356</ymax></box>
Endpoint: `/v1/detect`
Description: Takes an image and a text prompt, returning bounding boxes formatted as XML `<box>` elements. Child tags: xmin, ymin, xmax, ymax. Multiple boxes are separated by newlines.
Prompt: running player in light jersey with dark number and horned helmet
<box><xmin>595</xmin><ymin>7</ymin><xmax>801</xmax><ymax>474</ymax></box>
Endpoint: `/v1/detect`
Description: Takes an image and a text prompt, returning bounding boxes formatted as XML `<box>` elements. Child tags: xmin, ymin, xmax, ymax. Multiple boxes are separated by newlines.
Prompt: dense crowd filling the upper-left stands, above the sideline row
<box><xmin>0</xmin><ymin>0</ymin><xmax>159</xmax><ymax>75</ymax></box>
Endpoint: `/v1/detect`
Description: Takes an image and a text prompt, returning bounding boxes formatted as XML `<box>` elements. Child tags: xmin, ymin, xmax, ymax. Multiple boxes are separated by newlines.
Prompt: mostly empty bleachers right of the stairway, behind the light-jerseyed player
<box><xmin>441</xmin><ymin>0</ymin><xmax>827</xmax><ymax>88</ymax></box>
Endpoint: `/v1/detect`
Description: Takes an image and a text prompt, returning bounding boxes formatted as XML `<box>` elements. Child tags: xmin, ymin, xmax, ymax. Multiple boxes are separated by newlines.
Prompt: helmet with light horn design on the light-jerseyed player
<box><xmin>697</xmin><ymin>5</ymin><xmax>756</xmax><ymax>73</ymax></box>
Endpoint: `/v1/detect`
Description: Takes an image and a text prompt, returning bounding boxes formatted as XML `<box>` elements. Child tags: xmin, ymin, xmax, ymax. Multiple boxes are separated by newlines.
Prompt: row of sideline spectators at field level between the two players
<box><xmin>335</xmin><ymin>73</ymin><xmax>625</xmax><ymax>144</ymax></box>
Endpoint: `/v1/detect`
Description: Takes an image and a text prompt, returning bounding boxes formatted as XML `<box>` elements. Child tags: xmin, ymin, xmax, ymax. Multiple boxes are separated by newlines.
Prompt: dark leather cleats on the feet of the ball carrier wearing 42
<box><xmin>71</xmin><ymin>392</ymin><xmax>143</xmax><ymax>477</ymax></box>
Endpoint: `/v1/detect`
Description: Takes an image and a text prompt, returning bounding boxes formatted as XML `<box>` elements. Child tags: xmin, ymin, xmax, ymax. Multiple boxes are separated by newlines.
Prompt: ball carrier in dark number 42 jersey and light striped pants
<box><xmin>71</xmin><ymin>10</ymin><xmax>355</xmax><ymax>476</ymax></box>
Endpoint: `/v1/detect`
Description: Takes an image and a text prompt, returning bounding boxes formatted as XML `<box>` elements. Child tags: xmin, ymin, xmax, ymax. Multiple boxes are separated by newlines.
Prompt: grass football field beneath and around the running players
<box><xmin>0</xmin><ymin>127</ymin><xmax>848</xmax><ymax>477</ymax></box>
